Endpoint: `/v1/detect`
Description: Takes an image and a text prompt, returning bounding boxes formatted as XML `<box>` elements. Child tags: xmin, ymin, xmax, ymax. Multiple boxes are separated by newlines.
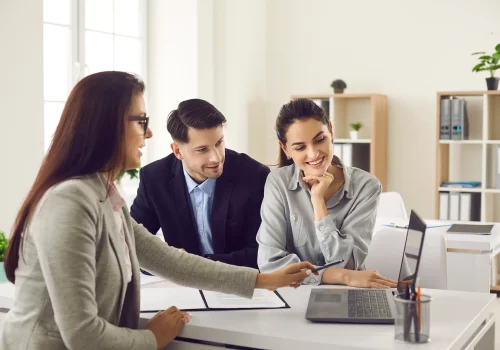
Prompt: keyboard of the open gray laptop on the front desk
<box><xmin>347</xmin><ymin>289</ymin><xmax>391</xmax><ymax>318</ymax></box>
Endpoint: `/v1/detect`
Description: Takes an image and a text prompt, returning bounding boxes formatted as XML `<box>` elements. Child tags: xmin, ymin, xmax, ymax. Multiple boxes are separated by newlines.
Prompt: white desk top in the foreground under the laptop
<box><xmin>141</xmin><ymin>286</ymin><xmax>495</xmax><ymax>350</ymax></box>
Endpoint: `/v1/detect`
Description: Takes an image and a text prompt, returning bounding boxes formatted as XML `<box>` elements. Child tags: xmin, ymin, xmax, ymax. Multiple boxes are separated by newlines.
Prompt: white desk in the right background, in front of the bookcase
<box><xmin>374</xmin><ymin>219</ymin><xmax>500</xmax><ymax>293</ymax></box>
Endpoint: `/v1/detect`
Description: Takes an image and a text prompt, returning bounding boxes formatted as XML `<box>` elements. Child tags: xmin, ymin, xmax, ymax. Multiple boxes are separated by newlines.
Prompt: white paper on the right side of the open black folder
<box><xmin>203</xmin><ymin>289</ymin><xmax>286</xmax><ymax>309</ymax></box>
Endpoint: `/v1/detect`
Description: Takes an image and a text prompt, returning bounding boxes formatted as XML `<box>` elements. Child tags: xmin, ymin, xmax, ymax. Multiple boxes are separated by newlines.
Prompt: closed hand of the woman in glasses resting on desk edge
<box><xmin>148</xmin><ymin>306</ymin><xmax>191</xmax><ymax>349</ymax></box>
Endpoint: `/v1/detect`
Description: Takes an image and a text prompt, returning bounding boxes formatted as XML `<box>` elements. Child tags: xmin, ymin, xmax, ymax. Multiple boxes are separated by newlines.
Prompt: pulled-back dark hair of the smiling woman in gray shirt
<box><xmin>275</xmin><ymin>98</ymin><xmax>329</xmax><ymax>168</ymax></box>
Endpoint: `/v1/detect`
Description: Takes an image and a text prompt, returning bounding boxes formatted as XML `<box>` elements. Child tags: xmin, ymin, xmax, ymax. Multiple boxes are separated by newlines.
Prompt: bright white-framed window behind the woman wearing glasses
<box><xmin>43</xmin><ymin>0</ymin><xmax>147</xmax><ymax>150</ymax></box>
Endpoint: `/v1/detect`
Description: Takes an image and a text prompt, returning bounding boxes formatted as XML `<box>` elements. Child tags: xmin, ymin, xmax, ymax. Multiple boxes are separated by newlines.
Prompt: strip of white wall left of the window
<box><xmin>0</xmin><ymin>0</ymin><xmax>43</xmax><ymax>232</ymax></box>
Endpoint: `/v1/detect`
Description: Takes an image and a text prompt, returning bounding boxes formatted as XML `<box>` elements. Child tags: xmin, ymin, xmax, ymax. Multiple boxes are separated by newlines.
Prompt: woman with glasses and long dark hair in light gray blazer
<box><xmin>0</xmin><ymin>72</ymin><xmax>312</xmax><ymax>350</ymax></box>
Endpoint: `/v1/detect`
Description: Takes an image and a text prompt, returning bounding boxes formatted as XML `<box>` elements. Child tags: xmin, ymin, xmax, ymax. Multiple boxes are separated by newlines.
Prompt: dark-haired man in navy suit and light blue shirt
<box><xmin>130</xmin><ymin>99</ymin><xmax>269</xmax><ymax>268</ymax></box>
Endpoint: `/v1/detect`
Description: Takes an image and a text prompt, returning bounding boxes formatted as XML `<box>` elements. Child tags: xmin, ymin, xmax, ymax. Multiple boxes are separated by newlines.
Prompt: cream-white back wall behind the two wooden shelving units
<box><xmin>214</xmin><ymin>0</ymin><xmax>500</xmax><ymax>217</ymax></box>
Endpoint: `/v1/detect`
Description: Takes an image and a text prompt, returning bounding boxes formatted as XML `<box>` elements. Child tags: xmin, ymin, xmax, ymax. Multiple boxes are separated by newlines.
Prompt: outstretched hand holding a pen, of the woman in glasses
<box><xmin>255</xmin><ymin>261</ymin><xmax>318</xmax><ymax>290</ymax></box>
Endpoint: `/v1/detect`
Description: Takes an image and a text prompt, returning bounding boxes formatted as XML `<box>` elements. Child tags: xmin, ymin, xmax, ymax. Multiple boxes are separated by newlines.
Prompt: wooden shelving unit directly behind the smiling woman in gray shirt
<box><xmin>291</xmin><ymin>94</ymin><xmax>387</xmax><ymax>191</ymax></box>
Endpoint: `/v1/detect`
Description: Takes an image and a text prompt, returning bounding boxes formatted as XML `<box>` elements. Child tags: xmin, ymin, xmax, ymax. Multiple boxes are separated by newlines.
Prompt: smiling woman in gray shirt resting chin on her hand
<box><xmin>257</xmin><ymin>99</ymin><xmax>396</xmax><ymax>288</ymax></box>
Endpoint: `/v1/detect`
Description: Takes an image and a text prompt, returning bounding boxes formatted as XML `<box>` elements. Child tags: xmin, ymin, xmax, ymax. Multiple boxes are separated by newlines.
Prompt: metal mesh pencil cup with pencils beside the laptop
<box><xmin>394</xmin><ymin>293</ymin><xmax>431</xmax><ymax>343</ymax></box>
